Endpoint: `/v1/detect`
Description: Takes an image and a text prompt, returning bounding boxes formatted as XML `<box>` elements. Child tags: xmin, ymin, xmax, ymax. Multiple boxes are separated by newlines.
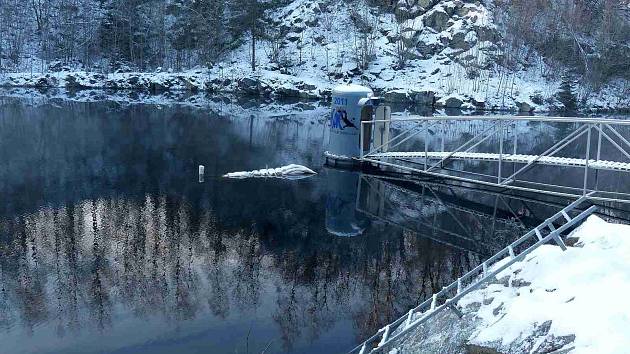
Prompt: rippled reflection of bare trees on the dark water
<box><xmin>0</xmin><ymin>195</ymin><xmax>477</xmax><ymax>350</ymax></box>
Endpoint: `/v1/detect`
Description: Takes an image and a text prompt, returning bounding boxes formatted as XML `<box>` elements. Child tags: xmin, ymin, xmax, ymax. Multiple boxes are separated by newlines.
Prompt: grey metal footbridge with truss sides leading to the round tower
<box><xmin>355</xmin><ymin>115</ymin><xmax>630</xmax><ymax>203</ymax></box>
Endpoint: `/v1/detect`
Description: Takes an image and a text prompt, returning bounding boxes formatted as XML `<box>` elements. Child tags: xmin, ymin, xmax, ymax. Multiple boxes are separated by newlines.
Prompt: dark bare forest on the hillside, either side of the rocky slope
<box><xmin>0</xmin><ymin>0</ymin><xmax>630</xmax><ymax>91</ymax></box>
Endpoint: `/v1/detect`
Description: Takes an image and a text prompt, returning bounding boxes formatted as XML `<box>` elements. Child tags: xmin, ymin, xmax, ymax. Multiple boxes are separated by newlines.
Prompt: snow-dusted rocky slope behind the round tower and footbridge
<box><xmin>256</xmin><ymin>0</ymin><xmax>629</xmax><ymax>111</ymax></box>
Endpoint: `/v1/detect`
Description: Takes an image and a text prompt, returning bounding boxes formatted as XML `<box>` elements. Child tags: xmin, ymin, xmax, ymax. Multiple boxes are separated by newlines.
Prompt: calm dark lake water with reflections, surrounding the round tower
<box><xmin>0</xmin><ymin>92</ymin><xmax>624</xmax><ymax>353</ymax></box>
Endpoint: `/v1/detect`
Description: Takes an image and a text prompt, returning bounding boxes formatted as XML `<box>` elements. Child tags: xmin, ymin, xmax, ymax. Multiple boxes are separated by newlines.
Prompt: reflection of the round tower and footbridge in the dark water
<box><xmin>326</xmin><ymin>169</ymin><xmax>588</xmax><ymax>255</ymax></box>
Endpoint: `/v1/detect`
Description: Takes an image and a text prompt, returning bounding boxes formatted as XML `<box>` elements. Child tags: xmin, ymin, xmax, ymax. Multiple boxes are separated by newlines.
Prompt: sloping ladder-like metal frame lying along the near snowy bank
<box><xmin>350</xmin><ymin>195</ymin><xmax>596</xmax><ymax>354</ymax></box>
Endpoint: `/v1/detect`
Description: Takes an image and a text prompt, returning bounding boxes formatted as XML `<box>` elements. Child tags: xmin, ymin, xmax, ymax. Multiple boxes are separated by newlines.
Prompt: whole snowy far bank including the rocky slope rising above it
<box><xmin>0</xmin><ymin>0</ymin><xmax>630</xmax><ymax>112</ymax></box>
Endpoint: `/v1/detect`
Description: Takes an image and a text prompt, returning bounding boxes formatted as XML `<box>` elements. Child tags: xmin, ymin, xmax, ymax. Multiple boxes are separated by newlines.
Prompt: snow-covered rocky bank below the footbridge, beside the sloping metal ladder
<box><xmin>390</xmin><ymin>216</ymin><xmax>630</xmax><ymax>354</ymax></box>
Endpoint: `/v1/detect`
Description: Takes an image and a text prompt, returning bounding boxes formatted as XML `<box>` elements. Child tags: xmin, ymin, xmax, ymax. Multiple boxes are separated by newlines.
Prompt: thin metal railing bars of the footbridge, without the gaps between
<box><xmin>359</xmin><ymin>115</ymin><xmax>630</xmax><ymax>203</ymax></box>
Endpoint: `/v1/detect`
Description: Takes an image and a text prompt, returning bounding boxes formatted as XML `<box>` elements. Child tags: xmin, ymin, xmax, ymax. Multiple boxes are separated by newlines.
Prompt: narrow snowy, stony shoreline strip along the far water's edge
<box><xmin>0</xmin><ymin>70</ymin><xmax>630</xmax><ymax>114</ymax></box>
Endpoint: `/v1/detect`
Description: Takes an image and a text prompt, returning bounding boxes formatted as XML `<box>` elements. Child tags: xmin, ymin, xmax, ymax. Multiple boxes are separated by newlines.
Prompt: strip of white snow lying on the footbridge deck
<box><xmin>367</xmin><ymin>151</ymin><xmax>630</xmax><ymax>171</ymax></box>
